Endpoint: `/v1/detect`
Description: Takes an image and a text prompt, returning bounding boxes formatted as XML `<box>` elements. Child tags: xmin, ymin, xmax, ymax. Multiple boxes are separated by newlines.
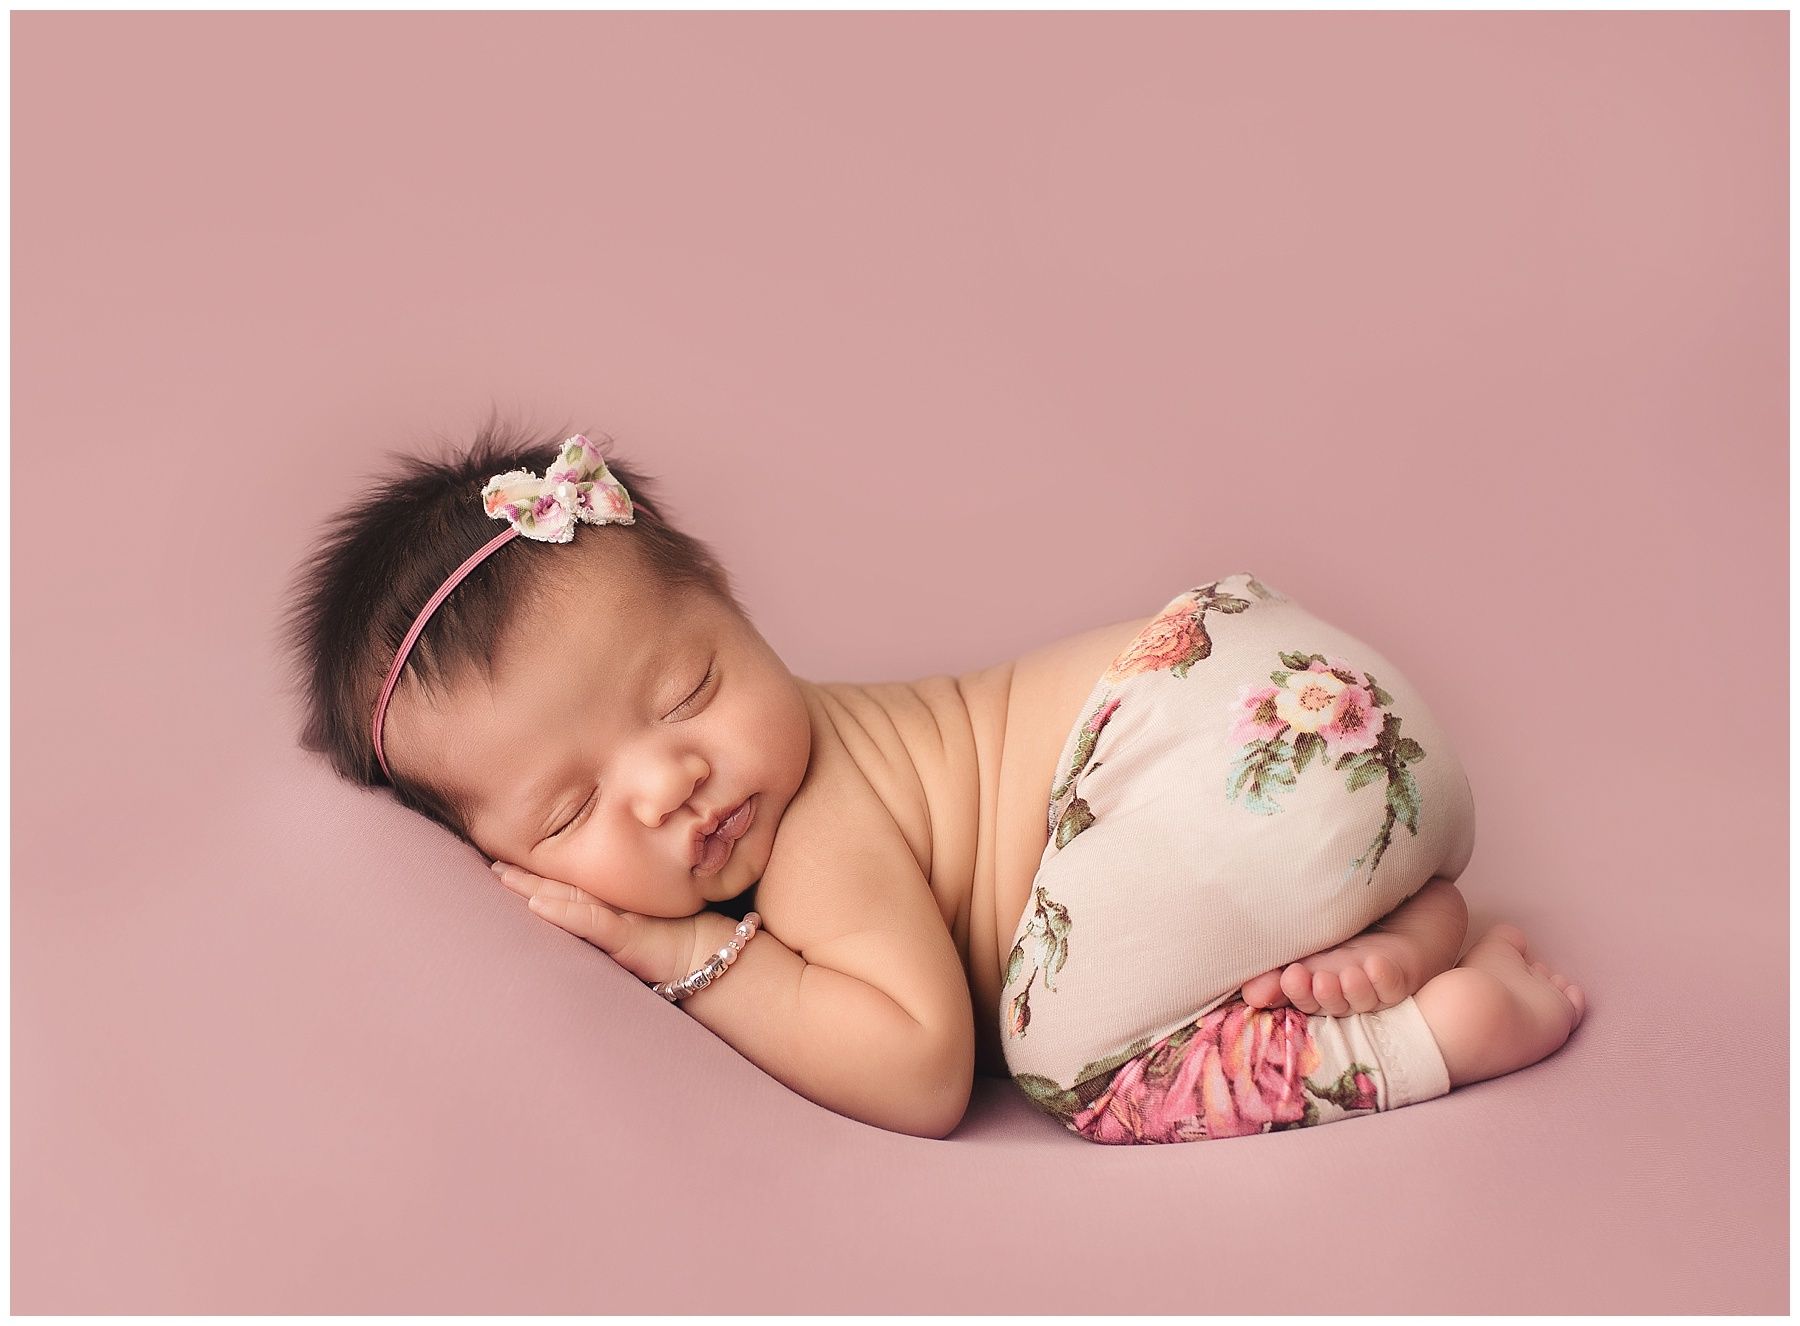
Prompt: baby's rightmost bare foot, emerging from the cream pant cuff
<box><xmin>1417</xmin><ymin>923</ymin><xmax>1588</xmax><ymax>1087</ymax></box>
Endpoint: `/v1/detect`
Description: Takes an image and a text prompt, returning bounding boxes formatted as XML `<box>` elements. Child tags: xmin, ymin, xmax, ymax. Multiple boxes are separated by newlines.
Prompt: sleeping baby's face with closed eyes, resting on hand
<box><xmin>394</xmin><ymin>564</ymin><xmax>812</xmax><ymax>916</ymax></box>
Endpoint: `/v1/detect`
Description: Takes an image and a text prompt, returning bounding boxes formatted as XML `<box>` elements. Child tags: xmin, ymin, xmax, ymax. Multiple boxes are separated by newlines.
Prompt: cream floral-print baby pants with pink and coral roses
<box><xmin>999</xmin><ymin>574</ymin><xmax>1474</xmax><ymax>1142</ymax></box>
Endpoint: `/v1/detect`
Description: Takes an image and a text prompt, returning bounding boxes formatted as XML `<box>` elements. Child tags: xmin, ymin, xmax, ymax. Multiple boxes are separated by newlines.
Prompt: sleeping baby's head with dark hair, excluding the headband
<box><xmin>286</xmin><ymin>421</ymin><xmax>812</xmax><ymax>916</ymax></box>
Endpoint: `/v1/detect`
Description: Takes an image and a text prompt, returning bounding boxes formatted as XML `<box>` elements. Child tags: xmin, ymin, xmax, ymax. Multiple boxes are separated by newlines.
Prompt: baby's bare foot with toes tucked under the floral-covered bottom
<box><xmin>1242</xmin><ymin>878</ymin><xmax>1469</xmax><ymax>1018</ymax></box>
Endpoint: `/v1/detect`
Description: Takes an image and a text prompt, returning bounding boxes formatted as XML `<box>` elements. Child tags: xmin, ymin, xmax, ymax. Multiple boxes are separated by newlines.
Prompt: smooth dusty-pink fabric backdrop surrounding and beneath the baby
<box><xmin>11</xmin><ymin>11</ymin><xmax>1787</xmax><ymax>1313</ymax></box>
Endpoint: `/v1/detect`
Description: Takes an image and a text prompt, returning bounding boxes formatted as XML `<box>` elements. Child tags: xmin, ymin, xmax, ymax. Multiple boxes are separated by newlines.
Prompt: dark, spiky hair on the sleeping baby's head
<box><xmin>281</xmin><ymin>414</ymin><xmax>745</xmax><ymax>846</ymax></box>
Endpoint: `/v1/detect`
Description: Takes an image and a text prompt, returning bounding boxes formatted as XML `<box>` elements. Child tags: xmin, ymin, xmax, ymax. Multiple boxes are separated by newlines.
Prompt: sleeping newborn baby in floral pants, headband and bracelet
<box><xmin>290</xmin><ymin>426</ymin><xmax>1584</xmax><ymax>1142</ymax></box>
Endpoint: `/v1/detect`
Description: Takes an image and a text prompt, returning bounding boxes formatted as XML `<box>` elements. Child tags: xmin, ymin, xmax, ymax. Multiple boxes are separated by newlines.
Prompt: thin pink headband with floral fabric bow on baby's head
<box><xmin>369</xmin><ymin>434</ymin><xmax>637</xmax><ymax>783</ymax></box>
